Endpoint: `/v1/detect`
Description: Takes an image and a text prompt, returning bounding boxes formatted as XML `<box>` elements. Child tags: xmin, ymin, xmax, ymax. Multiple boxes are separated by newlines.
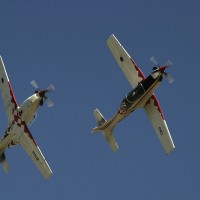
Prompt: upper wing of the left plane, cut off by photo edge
<box><xmin>0</xmin><ymin>56</ymin><xmax>18</xmax><ymax>122</ymax></box>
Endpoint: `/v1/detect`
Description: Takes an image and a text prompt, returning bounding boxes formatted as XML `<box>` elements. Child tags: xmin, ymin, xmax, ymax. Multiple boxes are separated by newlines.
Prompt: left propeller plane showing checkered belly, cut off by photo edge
<box><xmin>0</xmin><ymin>57</ymin><xmax>55</xmax><ymax>178</ymax></box>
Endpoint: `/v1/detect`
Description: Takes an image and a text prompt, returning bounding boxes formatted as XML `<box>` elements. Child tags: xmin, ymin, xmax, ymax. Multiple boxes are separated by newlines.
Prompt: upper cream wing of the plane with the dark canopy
<box><xmin>107</xmin><ymin>35</ymin><xmax>145</xmax><ymax>88</ymax></box>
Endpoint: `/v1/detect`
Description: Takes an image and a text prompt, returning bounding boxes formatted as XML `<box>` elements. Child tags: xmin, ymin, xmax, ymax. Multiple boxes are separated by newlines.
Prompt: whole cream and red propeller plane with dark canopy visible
<box><xmin>92</xmin><ymin>34</ymin><xmax>175</xmax><ymax>154</ymax></box>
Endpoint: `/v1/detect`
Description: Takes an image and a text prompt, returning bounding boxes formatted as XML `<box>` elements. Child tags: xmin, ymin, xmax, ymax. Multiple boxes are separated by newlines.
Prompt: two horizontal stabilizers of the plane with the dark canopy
<box><xmin>93</xmin><ymin>109</ymin><xmax>119</xmax><ymax>152</ymax></box>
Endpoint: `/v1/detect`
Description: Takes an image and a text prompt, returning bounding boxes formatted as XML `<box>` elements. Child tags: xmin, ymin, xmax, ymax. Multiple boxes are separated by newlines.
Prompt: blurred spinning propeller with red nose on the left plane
<box><xmin>30</xmin><ymin>80</ymin><xmax>55</xmax><ymax>107</ymax></box>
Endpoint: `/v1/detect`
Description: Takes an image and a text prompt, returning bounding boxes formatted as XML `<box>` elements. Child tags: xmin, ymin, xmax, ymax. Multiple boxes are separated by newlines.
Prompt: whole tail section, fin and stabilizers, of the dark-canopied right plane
<box><xmin>92</xmin><ymin>109</ymin><xmax>119</xmax><ymax>152</ymax></box>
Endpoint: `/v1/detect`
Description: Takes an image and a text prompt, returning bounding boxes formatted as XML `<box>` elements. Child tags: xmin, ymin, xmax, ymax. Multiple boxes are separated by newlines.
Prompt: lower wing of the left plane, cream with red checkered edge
<box><xmin>14</xmin><ymin>118</ymin><xmax>53</xmax><ymax>178</ymax></box>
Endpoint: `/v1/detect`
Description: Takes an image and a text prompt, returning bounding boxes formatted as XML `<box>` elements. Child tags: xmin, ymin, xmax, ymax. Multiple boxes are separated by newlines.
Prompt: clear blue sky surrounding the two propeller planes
<box><xmin>0</xmin><ymin>0</ymin><xmax>200</xmax><ymax>200</ymax></box>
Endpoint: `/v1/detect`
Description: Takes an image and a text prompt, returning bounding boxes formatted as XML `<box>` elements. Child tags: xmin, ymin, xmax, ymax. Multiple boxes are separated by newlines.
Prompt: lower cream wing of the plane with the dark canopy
<box><xmin>144</xmin><ymin>95</ymin><xmax>175</xmax><ymax>154</ymax></box>
